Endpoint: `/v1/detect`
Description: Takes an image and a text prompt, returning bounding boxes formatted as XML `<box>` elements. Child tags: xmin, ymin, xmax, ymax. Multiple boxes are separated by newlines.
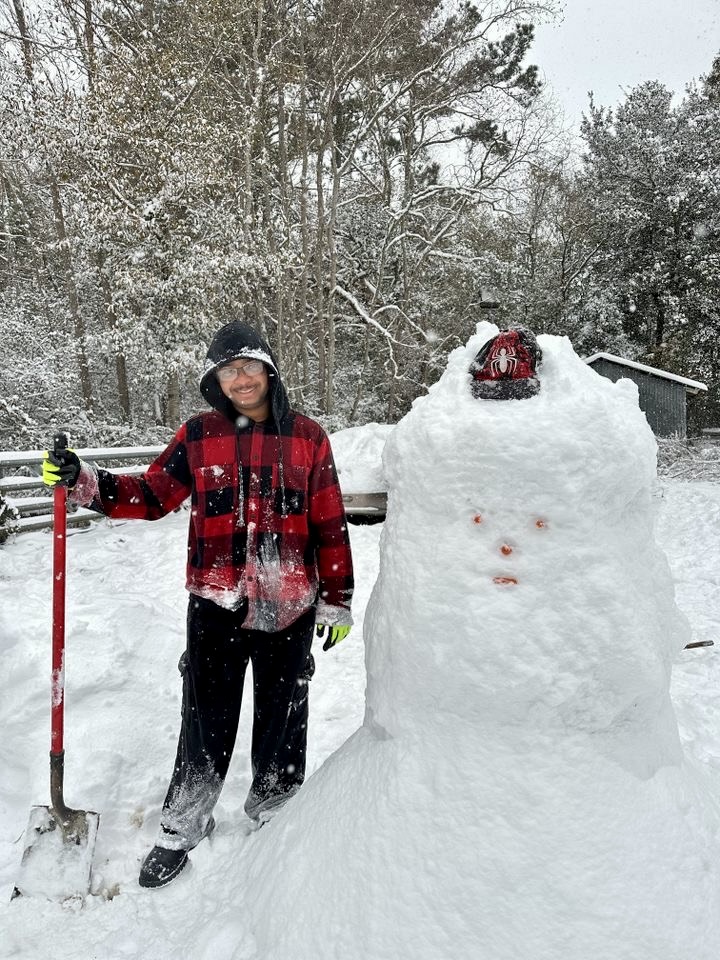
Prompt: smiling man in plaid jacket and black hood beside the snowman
<box><xmin>43</xmin><ymin>322</ymin><xmax>353</xmax><ymax>887</ymax></box>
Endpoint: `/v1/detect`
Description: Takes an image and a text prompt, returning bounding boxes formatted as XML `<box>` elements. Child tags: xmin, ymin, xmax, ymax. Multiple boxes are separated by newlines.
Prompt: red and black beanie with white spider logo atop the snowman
<box><xmin>470</xmin><ymin>327</ymin><xmax>542</xmax><ymax>400</ymax></box>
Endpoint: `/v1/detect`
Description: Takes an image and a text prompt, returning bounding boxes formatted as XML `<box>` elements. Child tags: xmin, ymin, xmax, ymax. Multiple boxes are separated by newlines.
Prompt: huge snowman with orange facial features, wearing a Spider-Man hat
<box><xmin>239</xmin><ymin>324</ymin><xmax>720</xmax><ymax>960</ymax></box>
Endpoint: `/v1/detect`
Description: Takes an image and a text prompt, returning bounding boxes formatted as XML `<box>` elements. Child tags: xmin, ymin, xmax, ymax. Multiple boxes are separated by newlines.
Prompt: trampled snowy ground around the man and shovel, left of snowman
<box><xmin>0</xmin><ymin>511</ymin><xmax>381</xmax><ymax>960</ymax></box>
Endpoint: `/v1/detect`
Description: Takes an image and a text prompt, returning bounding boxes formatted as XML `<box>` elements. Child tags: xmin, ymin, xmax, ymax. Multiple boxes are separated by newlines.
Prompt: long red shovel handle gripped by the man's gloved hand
<box><xmin>50</xmin><ymin>435</ymin><xmax>67</xmax><ymax>754</ymax></box>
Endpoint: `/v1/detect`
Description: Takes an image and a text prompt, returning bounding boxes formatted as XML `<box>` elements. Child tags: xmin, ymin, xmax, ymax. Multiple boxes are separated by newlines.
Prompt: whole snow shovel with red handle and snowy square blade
<box><xmin>12</xmin><ymin>434</ymin><xmax>100</xmax><ymax>900</ymax></box>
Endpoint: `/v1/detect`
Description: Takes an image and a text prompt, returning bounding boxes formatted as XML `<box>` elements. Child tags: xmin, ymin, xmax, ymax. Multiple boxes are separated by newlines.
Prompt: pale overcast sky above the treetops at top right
<box><xmin>528</xmin><ymin>0</ymin><xmax>720</xmax><ymax>124</ymax></box>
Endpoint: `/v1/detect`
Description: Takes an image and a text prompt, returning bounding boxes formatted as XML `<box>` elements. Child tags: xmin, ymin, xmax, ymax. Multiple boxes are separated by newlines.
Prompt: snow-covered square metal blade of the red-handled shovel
<box><xmin>12</xmin><ymin>807</ymin><xmax>100</xmax><ymax>900</ymax></box>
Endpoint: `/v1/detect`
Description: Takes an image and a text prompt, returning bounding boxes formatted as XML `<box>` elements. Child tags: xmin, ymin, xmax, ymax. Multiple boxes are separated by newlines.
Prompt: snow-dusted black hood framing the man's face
<box><xmin>200</xmin><ymin>320</ymin><xmax>290</xmax><ymax>426</ymax></box>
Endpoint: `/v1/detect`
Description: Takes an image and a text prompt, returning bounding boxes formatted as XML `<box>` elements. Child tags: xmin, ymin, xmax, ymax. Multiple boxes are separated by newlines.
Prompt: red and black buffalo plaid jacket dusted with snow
<box><xmin>72</xmin><ymin>411</ymin><xmax>353</xmax><ymax>632</ymax></box>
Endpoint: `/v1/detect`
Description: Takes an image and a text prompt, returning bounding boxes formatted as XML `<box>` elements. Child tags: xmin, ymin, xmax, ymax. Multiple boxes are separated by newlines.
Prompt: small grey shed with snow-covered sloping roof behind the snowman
<box><xmin>585</xmin><ymin>353</ymin><xmax>707</xmax><ymax>437</ymax></box>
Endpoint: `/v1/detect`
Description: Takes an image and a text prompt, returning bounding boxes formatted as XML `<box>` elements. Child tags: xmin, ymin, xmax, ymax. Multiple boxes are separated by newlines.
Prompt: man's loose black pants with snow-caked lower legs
<box><xmin>159</xmin><ymin>596</ymin><xmax>315</xmax><ymax>849</ymax></box>
